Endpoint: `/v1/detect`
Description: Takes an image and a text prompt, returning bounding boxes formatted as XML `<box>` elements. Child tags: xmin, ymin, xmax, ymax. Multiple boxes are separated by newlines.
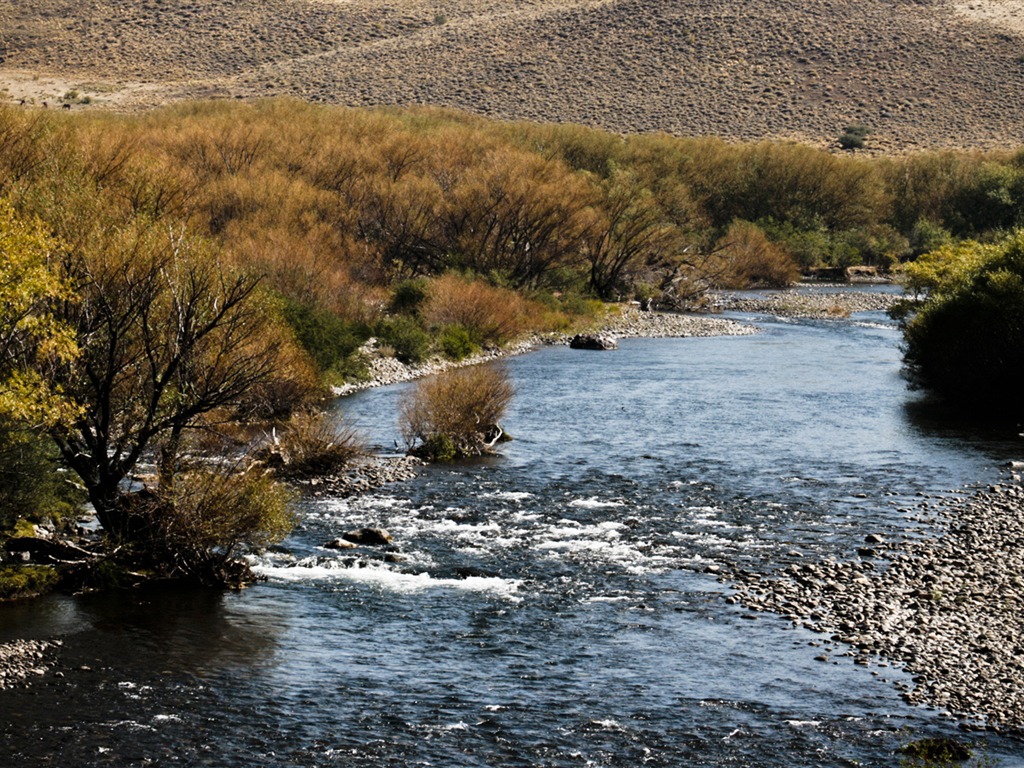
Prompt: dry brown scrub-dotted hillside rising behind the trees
<box><xmin>0</xmin><ymin>0</ymin><xmax>1024</xmax><ymax>150</ymax></box>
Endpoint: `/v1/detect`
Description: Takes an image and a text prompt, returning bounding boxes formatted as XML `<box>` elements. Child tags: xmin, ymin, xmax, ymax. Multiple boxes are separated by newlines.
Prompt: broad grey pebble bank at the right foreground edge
<box><xmin>726</xmin><ymin>479</ymin><xmax>1024</xmax><ymax>729</ymax></box>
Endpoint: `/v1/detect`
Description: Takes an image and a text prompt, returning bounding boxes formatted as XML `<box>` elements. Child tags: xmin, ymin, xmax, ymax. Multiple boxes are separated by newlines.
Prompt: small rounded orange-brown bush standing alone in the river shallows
<box><xmin>398</xmin><ymin>365</ymin><xmax>515</xmax><ymax>461</ymax></box>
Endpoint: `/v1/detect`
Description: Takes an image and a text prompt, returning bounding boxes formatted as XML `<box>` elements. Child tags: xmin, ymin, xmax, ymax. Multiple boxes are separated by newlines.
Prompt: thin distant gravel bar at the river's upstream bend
<box><xmin>711</xmin><ymin>291</ymin><xmax>903</xmax><ymax>317</ymax></box>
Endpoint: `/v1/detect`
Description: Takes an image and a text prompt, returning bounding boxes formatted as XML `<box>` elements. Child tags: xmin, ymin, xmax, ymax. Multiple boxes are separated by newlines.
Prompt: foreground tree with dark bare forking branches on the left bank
<box><xmin>40</xmin><ymin>219</ymin><xmax>311</xmax><ymax>537</ymax></box>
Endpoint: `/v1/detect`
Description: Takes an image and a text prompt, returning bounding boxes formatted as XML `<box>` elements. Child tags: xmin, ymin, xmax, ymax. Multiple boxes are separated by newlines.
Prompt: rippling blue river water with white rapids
<box><xmin>0</xmin><ymin>292</ymin><xmax>1024</xmax><ymax>767</ymax></box>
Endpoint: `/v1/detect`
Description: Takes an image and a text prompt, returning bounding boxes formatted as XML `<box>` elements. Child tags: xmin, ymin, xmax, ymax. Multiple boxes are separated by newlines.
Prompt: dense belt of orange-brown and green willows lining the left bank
<box><xmin>0</xmin><ymin>100</ymin><xmax>1024</xmax><ymax>598</ymax></box>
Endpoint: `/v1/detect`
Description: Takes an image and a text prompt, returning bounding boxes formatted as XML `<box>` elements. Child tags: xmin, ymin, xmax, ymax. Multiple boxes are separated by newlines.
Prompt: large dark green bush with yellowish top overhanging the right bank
<box><xmin>904</xmin><ymin>231</ymin><xmax>1024</xmax><ymax>419</ymax></box>
